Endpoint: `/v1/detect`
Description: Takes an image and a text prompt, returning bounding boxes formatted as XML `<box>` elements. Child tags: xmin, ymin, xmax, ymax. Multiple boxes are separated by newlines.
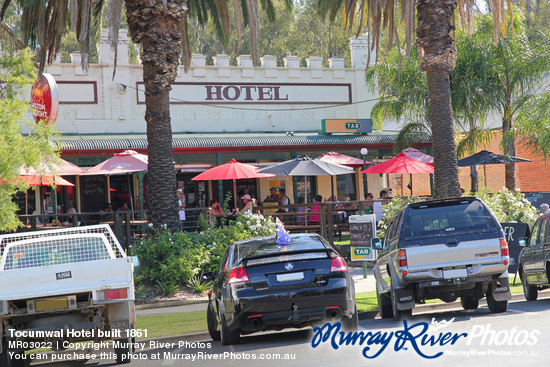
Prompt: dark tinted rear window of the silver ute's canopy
<box><xmin>404</xmin><ymin>200</ymin><xmax>495</xmax><ymax>237</ymax></box>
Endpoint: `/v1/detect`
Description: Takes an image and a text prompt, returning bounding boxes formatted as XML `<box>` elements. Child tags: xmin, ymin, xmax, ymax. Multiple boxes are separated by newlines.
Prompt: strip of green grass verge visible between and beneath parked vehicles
<box><xmin>136</xmin><ymin>277</ymin><xmax>523</xmax><ymax>338</ymax></box>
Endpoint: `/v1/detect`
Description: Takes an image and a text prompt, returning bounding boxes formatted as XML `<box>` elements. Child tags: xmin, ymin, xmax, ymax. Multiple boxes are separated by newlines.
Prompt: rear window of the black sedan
<box><xmin>229</xmin><ymin>235</ymin><xmax>328</xmax><ymax>266</ymax></box>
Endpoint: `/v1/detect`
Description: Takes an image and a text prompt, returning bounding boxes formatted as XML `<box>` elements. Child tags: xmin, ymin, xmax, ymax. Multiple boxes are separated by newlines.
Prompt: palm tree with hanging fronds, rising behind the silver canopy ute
<box><xmin>318</xmin><ymin>0</ymin><xmax>511</xmax><ymax>198</ymax></box>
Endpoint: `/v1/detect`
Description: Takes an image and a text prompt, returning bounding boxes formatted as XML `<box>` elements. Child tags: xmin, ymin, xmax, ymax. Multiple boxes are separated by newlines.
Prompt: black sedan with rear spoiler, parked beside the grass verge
<box><xmin>207</xmin><ymin>234</ymin><xmax>358</xmax><ymax>345</ymax></box>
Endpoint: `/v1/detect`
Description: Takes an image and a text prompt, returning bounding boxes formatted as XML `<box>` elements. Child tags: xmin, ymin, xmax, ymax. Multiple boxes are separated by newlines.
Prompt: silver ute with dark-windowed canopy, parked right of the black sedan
<box><xmin>372</xmin><ymin>197</ymin><xmax>511</xmax><ymax>319</ymax></box>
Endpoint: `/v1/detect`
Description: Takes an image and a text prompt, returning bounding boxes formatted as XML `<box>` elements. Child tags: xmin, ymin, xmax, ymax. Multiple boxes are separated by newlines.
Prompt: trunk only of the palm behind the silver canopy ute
<box><xmin>417</xmin><ymin>0</ymin><xmax>461</xmax><ymax>198</ymax></box>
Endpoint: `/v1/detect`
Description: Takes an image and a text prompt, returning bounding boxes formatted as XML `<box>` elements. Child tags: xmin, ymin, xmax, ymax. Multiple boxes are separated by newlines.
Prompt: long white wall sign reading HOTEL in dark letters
<box><xmin>137</xmin><ymin>82</ymin><xmax>352</xmax><ymax>105</ymax></box>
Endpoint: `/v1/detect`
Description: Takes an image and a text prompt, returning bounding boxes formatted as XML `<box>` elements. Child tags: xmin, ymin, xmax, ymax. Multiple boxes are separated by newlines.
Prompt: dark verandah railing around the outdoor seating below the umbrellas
<box><xmin>19</xmin><ymin>200</ymin><xmax>380</xmax><ymax>250</ymax></box>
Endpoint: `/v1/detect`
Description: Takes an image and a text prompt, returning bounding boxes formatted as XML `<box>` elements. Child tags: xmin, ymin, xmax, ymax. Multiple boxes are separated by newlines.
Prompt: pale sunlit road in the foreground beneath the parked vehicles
<box><xmin>33</xmin><ymin>299</ymin><xmax>550</xmax><ymax>367</ymax></box>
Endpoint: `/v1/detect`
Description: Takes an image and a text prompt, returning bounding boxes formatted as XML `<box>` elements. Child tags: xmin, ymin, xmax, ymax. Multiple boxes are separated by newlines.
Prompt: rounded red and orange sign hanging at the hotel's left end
<box><xmin>31</xmin><ymin>74</ymin><xmax>59</xmax><ymax>125</ymax></box>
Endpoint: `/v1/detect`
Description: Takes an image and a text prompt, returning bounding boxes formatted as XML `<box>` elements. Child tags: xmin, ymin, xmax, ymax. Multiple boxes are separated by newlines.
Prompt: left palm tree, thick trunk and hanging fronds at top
<box><xmin>0</xmin><ymin>0</ymin><xmax>286</xmax><ymax>230</ymax></box>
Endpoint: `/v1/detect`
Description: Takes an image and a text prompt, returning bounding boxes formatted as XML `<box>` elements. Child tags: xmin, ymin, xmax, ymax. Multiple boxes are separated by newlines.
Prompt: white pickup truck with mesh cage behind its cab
<box><xmin>0</xmin><ymin>225</ymin><xmax>135</xmax><ymax>366</ymax></box>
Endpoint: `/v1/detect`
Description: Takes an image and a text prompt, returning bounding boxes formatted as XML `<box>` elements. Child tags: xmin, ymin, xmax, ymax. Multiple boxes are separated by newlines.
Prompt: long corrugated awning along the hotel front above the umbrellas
<box><xmin>54</xmin><ymin>133</ymin><xmax>432</xmax><ymax>156</ymax></box>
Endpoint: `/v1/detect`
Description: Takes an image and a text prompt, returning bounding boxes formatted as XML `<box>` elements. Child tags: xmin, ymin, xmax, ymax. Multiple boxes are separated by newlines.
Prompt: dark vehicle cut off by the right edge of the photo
<box><xmin>518</xmin><ymin>214</ymin><xmax>550</xmax><ymax>301</ymax></box>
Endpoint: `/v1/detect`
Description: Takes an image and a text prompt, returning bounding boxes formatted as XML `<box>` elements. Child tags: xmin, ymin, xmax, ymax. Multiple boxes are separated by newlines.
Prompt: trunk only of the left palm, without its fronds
<box><xmin>125</xmin><ymin>0</ymin><xmax>187</xmax><ymax>230</ymax></box>
